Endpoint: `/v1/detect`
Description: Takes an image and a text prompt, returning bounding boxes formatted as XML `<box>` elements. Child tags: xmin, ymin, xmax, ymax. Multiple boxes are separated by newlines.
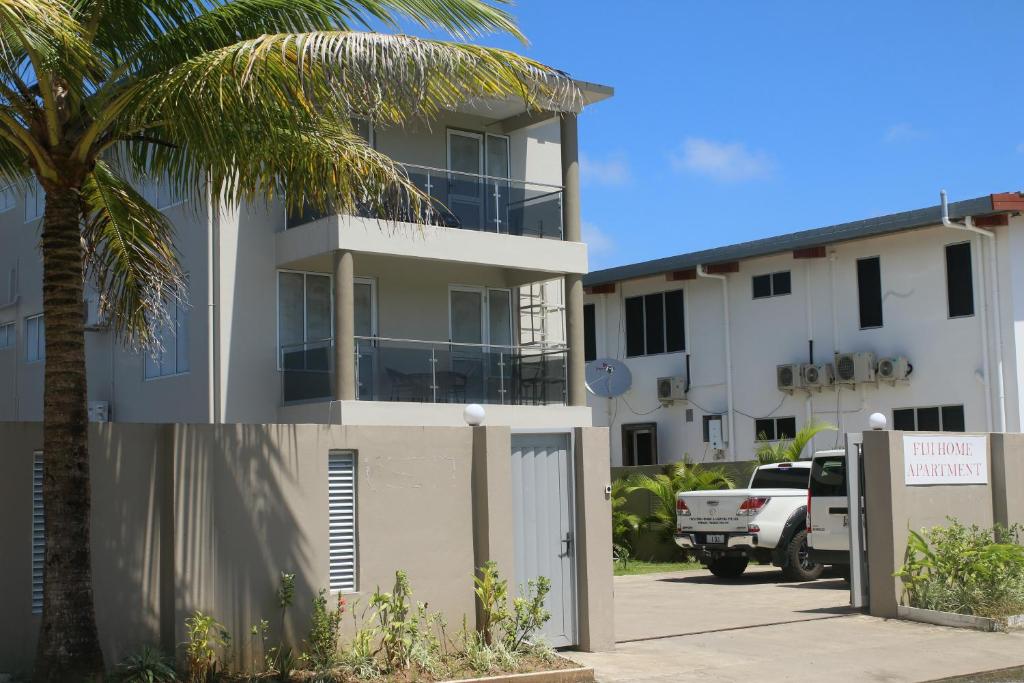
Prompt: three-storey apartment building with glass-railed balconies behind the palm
<box><xmin>0</xmin><ymin>82</ymin><xmax>612</xmax><ymax>427</ymax></box>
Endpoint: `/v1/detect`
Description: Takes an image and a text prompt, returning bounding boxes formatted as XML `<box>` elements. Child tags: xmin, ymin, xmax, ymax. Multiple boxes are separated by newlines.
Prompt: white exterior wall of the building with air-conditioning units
<box><xmin>587</xmin><ymin>218</ymin><xmax>1024</xmax><ymax>465</ymax></box>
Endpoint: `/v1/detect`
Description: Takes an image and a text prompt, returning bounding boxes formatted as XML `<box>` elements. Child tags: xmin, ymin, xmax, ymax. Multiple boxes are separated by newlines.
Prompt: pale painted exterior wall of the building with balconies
<box><xmin>0</xmin><ymin>114</ymin><xmax>589</xmax><ymax>426</ymax></box>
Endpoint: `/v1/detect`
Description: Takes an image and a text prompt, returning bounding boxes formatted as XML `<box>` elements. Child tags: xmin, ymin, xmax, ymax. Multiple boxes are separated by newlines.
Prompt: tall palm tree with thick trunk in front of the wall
<box><xmin>0</xmin><ymin>0</ymin><xmax>581</xmax><ymax>681</ymax></box>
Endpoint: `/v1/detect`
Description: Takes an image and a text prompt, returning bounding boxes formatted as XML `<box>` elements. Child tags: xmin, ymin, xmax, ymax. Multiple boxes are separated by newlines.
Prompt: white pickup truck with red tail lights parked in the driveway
<box><xmin>675</xmin><ymin>461</ymin><xmax>823</xmax><ymax>581</ymax></box>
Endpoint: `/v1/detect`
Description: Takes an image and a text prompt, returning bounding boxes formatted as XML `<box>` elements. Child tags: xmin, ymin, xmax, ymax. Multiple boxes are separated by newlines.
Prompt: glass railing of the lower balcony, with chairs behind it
<box><xmin>281</xmin><ymin>337</ymin><xmax>567</xmax><ymax>405</ymax></box>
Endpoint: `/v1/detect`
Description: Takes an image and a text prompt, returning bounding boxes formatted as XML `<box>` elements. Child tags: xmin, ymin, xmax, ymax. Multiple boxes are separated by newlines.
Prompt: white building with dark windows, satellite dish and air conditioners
<box><xmin>584</xmin><ymin>193</ymin><xmax>1024</xmax><ymax>465</ymax></box>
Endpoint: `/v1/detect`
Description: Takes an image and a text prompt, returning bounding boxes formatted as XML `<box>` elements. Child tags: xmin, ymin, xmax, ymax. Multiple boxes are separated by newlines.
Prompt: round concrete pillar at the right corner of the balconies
<box><xmin>559</xmin><ymin>114</ymin><xmax>587</xmax><ymax>405</ymax></box>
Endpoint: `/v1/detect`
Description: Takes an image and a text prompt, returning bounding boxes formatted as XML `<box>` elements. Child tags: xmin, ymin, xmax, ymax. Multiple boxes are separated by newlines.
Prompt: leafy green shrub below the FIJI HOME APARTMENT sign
<box><xmin>894</xmin><ymin>519</ymin><xmax>1024</xmax><ymax>618</ymax></box>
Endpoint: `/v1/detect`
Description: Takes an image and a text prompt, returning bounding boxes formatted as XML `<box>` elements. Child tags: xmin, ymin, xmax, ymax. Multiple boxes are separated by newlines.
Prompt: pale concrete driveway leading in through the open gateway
<box><xmin>566</xmin><ymin>567</ymin><xmax>1024</xmax><ymax>683</ymax></box>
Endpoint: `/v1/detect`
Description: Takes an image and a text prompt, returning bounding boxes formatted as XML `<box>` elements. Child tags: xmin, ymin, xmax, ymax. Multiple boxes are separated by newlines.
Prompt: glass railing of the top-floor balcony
<box><xmin>288</xmin><ymin>164</ymin><xmax>562</xmax><ymax>240</ymax></box>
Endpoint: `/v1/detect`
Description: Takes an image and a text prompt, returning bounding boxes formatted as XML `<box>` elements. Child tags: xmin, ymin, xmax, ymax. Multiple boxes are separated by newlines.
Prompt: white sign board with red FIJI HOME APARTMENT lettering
<box><xmin>903</xmin><ymin>434</ymin><xmax>988</xmax><ymax>486</ymax></box>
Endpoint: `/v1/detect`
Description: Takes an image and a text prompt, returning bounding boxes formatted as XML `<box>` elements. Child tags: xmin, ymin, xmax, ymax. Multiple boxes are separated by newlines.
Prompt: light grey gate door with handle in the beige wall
<box><xmin>512</xmin><ymin>433</ymin><xmax>578</xmax><ymax>647</ymax></box>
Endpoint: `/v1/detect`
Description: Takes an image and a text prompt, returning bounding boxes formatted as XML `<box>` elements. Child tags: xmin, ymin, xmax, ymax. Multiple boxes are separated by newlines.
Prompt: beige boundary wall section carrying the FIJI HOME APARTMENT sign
<box><xmin>864</xmin><ymin>431</ymin><xmax>1024</xmax><ymax>618</ymax></box>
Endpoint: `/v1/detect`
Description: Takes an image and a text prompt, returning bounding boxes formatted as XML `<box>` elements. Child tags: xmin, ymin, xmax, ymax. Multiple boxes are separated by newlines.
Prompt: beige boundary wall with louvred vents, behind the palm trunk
<box><xmin>0</xmin><ymin>423</ymin><xmax>613</xmax><ymax>672</ymax></box>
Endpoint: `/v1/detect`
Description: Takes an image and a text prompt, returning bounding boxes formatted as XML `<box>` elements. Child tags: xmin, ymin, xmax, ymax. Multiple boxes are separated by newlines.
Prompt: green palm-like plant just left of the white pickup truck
<box><xmin>626</xmin><ymin>460</ymin><xmax>736</xmax><ymax>540</ymax></box>
